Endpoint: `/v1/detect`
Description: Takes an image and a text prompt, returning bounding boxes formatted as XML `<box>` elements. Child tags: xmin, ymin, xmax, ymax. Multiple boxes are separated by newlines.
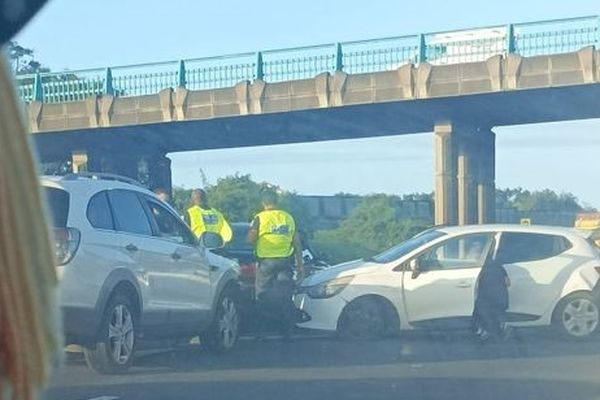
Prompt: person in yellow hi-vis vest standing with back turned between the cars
<box><xmin>248</xmin><ymin>193</ymin><xmax>304</xmax><ymax>339</ymax></box>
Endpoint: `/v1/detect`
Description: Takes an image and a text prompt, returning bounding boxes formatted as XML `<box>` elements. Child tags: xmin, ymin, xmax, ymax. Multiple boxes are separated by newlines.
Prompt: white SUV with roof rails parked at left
<box><xmin>41</xmin><ymin>174</ymin><xmax>239</xmax><ymax>373</ymax></box>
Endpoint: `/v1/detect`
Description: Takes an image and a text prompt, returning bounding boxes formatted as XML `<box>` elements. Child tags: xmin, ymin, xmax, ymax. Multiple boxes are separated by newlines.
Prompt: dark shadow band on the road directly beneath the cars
<box><xmin>110</xmin><ymin>331</ymin><xmax>600</xmax><ymax>374</ymax></box>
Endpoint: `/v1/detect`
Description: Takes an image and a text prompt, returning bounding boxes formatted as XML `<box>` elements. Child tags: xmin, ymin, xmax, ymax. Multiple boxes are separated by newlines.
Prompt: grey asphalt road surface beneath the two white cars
<box><xmin>45</xmin><ymin>331</ymin><xmax>600</xmax><ymax>400</ymax></box>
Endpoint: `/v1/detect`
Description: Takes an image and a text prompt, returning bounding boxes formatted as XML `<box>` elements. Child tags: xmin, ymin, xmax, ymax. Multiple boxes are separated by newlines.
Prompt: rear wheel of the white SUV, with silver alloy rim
<box><xmin>83</xmin><ymin>294</ymin><xmax>137</xmax><ymax>374</ymax></box>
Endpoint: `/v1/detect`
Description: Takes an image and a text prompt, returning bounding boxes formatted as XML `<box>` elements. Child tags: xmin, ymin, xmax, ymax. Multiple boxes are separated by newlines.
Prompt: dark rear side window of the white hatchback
<box><xmin>497</xmin><ymin>232</ymin><xmax>572</xmax><ymax>264</ymax></box>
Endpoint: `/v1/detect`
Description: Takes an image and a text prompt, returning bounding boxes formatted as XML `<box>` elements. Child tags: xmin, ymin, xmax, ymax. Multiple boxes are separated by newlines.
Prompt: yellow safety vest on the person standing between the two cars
<box><xmin>256</xmin><ymin>210</ymin><xmax>296</xmax><ymax>258</ymax></box>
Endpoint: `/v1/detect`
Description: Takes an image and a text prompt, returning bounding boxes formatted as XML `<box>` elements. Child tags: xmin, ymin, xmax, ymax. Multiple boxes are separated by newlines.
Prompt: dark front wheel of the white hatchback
<box><xmin>337</xmin><ymin>297</ymin><xmax>386</xmax><ymax>340</ymax></box>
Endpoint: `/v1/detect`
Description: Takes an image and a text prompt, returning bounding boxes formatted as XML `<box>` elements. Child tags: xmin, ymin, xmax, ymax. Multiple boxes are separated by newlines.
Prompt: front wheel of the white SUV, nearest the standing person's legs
<box><xmin>200</xmin><ymin>286</ymin><xmax>240</xmax><ymax>353</ymax></box>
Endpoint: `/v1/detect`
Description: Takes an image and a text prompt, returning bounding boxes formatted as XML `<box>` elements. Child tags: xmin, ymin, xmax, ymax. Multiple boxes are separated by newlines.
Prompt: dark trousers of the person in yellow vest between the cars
<box><xmin>256</xmin><ymin>257</ymin><xmax>297</xmax><ymax>335</ymax></box>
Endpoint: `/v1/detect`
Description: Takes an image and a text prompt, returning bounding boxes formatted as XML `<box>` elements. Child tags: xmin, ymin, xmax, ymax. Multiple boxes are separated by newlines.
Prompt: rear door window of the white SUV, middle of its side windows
<box><xmin>108</xmin><ymin>189</ymin><xmax>152</xmax><ymax>236</ymax></box>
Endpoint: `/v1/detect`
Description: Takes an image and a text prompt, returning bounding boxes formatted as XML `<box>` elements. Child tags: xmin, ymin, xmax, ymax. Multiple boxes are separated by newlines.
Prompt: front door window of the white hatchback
<box><xmin>417</xmin><ymin>232</ymin><xmax>494</xmax><ymax>271</ymax></box>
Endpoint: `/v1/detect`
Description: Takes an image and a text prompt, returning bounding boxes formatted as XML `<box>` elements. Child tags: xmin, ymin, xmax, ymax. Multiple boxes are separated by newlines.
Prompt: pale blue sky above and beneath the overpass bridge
<box><xmin>16</xmin><ymin>0</ymin><xmax>600</xmax><ymax>208</ymax></box>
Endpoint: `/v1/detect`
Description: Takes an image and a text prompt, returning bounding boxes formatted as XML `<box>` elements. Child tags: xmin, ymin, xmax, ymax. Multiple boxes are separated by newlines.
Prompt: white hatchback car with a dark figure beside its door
<box><xmin>295</xmin><ymin>225</ymin><xmax>600</xmax><ymax>338</ymax></box>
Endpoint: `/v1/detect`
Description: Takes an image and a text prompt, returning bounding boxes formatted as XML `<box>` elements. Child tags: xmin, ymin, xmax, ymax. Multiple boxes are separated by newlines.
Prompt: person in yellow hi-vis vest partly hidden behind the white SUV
<box><xmin>186</xmin><ymin>189</ymin><xmax>233</xmax><ymax>243</ymax></box>
